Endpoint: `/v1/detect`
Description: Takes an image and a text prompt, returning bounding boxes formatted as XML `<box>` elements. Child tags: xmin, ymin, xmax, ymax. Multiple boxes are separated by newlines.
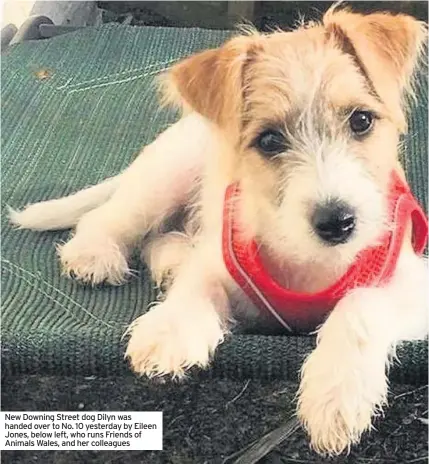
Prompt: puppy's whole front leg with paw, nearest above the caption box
<box><xmin>126</xmin><ymin>243</ymin><xmax>229</xmax><ymax>377</ymax></box>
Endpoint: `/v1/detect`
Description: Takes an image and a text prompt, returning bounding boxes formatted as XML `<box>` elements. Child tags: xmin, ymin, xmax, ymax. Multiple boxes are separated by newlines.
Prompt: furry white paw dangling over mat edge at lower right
<box><xmin>298</xmin><ymin>346</ymin><xmax>387</xmax><ymax>456</ymax></box>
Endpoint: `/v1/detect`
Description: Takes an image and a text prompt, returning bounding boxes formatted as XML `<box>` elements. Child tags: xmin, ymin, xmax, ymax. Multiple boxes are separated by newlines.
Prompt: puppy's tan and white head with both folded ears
<box><xmin>163</xmin><ymin>9</ymin><xmax>426</xmax><ymax>290</ymax></box>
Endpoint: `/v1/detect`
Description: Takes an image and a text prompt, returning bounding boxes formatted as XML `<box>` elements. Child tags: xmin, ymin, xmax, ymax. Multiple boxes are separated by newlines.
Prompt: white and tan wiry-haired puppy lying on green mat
<box><xmin>11</xmin><ymin>6</ymin><xmax>428</xmax><ymax>455</ymax></box>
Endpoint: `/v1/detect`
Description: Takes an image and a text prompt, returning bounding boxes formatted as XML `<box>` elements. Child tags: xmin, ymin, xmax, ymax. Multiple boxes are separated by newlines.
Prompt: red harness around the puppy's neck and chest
<box><xmin>222</xmin><ymin>172</ymin><xmax>428</xmax><ymax>332</ymax></box>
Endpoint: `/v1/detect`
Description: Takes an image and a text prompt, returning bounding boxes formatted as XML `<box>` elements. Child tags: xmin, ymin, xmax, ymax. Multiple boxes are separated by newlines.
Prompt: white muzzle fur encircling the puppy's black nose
<box><xmin>273</xmin><ymin>133</ymin><xmax>386</xmax><ymax>272</ymax></box>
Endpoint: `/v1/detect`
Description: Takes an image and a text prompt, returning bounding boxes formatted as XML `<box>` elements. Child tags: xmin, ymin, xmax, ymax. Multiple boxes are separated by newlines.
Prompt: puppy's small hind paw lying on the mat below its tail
<box><xmin>58</xmin><ymin>234</ymin><xmax>130</xmax><ymax>285</ymax></box>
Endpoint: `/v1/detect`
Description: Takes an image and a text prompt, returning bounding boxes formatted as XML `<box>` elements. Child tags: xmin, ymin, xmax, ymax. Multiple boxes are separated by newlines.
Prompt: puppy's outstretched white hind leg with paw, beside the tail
<box><xmin>37</xmin><ymin>114</ymin><xmax>214</xmax><ymax>284</ymax></box>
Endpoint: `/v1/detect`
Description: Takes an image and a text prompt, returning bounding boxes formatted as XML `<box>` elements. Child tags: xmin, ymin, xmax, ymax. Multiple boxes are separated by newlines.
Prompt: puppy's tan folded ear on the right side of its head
<box><xmin>323</xmin><ymin>8</ymin><xmax>427</xmax><ymax>129</ymax></box>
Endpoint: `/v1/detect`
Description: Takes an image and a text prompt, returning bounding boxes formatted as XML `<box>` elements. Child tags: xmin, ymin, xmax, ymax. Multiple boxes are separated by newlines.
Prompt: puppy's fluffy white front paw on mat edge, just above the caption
<box><xmin>125</xmin><ymin>300</ymin><xmax>224</xmax><ymax>377</ymax></box>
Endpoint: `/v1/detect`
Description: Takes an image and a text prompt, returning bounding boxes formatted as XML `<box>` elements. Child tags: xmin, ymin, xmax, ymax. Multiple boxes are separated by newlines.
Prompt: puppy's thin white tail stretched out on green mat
<box><xmin>9</xmin><ymin>175</ymin><xmax>120</xmax><ymax>230</ymax></box>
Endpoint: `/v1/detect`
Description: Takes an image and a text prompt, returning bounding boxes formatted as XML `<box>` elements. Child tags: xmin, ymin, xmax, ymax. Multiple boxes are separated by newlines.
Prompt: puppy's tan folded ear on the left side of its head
<box><xmin>163</xmin><ymin>35</ymin><xmax>260</xmax><ymax>137</ymax></box>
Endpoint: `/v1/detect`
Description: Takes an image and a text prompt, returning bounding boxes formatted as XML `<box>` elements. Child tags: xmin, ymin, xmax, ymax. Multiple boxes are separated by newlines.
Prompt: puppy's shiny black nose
<box><xmin>311</xmin><ymin>200</ymin><xmax>356</xmax><ymax>246</ymax></box>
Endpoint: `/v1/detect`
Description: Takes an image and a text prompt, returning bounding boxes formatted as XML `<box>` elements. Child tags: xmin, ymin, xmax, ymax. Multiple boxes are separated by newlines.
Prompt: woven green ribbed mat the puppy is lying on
<box><xmin>1</xmin><ymin>25</ymin><xmax>427</xmax><ymax>383</ymax></box>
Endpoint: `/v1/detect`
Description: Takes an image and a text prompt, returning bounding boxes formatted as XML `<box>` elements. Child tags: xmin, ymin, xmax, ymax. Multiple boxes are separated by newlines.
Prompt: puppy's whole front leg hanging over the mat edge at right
<box><xmin>298</xmin><ymin>248</ymin><xmax>428</xmax><ymax>455</ymax></box>
